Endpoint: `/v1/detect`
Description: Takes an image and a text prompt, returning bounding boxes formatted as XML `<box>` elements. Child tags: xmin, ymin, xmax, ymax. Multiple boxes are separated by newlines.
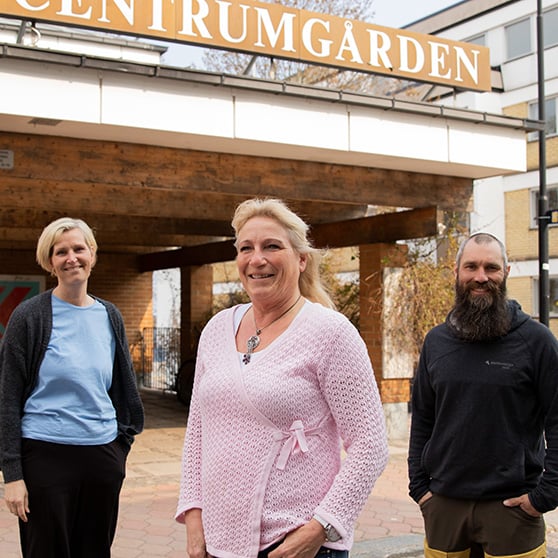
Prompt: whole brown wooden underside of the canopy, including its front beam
<box><xmin>0</xmin><ymin>132</ymin><xmax>472</xmax><ymax>264</ymax></box>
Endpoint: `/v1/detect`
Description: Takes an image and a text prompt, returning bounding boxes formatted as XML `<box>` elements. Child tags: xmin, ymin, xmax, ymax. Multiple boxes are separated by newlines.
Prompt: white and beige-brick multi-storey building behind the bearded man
<box><xmin>410</xmin><ymin>0</ymin><xmax>558</xmax><ymax>334</ymax></box>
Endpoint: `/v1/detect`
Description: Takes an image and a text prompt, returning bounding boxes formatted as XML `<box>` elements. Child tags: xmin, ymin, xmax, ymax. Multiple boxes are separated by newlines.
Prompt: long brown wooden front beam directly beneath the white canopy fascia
<box><xmin>0</xmin><ymin>132</ymin><xmax>472</xmax><ymax>212</ymax></box>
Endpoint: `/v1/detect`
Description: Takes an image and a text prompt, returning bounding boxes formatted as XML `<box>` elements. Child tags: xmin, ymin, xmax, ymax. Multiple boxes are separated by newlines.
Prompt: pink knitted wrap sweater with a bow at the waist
<box><xmin>176</xmin><ymin>304</ymin><xmax>388</xmax><ymax>558</ymax></box>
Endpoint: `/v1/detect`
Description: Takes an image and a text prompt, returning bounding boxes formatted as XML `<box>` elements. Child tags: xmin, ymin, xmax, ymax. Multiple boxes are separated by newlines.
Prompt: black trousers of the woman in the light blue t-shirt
<box><xmin>19</xmin><ymin>439</ymin><xmax>129</xmax><ymax>558</ymax></box>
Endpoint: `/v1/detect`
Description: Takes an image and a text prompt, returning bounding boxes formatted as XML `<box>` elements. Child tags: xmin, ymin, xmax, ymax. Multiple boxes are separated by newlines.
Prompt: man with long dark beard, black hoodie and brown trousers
<box><xmin>408</xmin><ymin>233</ymin><xmax>558</xmax><ymax>558</ymax></box>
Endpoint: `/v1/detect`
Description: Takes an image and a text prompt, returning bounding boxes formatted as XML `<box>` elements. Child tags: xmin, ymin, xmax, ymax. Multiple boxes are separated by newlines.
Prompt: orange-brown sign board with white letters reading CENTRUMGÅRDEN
<box><xmin>0</xmin><ymin>0</ymin><xmax>491</xmax><ymax>91</ymax></box>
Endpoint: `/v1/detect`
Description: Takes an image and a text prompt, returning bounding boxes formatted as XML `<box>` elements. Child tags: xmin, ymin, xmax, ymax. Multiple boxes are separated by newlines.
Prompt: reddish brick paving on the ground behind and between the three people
<box><xmin>0</xmin><ymin>390</ymin><xmax>558</xmax><ymax>558</ymax></box>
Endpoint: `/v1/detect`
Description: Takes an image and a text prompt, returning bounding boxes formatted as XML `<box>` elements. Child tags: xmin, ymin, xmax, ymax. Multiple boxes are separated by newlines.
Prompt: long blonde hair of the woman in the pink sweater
<box><xmin>232</xmin><ymin>198</ymin><xmax>335</xmax><ymax>308</ymax></box>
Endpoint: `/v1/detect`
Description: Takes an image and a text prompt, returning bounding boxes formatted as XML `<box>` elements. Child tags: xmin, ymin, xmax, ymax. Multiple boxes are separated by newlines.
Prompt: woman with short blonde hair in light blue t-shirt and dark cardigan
<box><xmin>0</xmin><ymin>217</ymin><xmax>143</xmax><ymax>558</ymax></box>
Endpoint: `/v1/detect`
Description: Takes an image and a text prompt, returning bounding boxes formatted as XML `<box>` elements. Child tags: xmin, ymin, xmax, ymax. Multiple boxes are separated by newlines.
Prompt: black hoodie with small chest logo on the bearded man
<box><xmin>409</xmin><ymin>301</ymin><xmax>558</xmax><ymax>513</ymax></box>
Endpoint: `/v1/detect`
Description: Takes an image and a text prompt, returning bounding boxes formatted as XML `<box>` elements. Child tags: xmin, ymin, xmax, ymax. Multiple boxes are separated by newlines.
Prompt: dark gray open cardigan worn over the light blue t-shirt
<box><xmin>0</xmin><ymin>290</ymin><xmax>144</xmax><ymax>482</ymax></box>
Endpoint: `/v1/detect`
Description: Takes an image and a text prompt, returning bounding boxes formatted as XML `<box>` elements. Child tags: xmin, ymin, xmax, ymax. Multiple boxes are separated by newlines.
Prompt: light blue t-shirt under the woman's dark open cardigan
<box><xmin>22</xmin><ymin>295</ymin><xmax>117</xmax><ymax>446</ymax></box>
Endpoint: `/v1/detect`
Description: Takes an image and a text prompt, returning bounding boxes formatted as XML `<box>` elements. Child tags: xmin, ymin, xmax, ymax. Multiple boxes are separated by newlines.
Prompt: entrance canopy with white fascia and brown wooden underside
<box><xmin>0</xmin><ymin>39</ymin><xmax>536</xmax><ymax>269</ymax></box>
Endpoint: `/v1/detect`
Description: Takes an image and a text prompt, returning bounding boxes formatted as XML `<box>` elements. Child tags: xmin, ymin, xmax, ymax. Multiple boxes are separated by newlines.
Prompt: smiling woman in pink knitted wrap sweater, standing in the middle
<box><xmin>176</xmin><ymin>199</ymin><xmax>388</xmax><ymax>558</ymax></box>
